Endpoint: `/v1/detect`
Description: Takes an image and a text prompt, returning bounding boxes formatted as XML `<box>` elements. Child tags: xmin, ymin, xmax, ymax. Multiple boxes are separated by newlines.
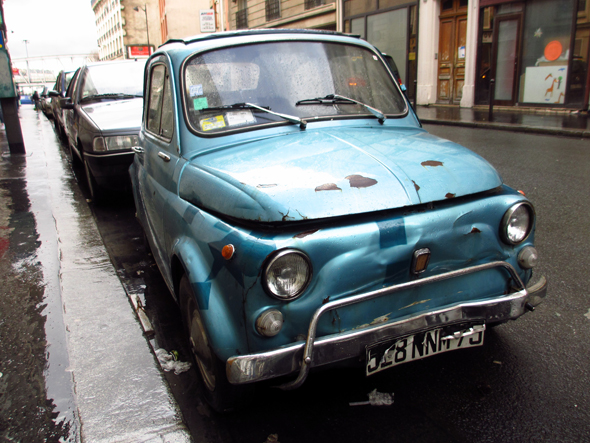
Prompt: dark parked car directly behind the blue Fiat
<box><xmin>61</xmin><ymin>60</ymin><xmax>145</xmax><ymax>200</ymax></box>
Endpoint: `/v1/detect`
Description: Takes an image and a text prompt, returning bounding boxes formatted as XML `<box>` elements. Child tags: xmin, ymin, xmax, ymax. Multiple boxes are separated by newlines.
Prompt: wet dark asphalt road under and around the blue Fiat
<box><xmin>2</xmin><ymin>110</ymin><xmax>590</xmax><ymax>443</ymax></box>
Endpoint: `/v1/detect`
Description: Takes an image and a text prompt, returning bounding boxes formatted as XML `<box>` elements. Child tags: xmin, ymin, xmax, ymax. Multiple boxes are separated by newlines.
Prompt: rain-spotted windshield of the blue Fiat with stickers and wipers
<box><xmin>184</xmin><ymin>42</ymin><xmax>406</xmax><ymax>133</ymax></box>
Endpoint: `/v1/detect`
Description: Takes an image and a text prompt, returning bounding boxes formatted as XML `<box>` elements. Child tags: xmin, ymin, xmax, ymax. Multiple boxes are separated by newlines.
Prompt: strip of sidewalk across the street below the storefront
<box><xmin>416</xmin><ymin>105</ymin><xmax>590</xmax><ymax>138</ymax></box>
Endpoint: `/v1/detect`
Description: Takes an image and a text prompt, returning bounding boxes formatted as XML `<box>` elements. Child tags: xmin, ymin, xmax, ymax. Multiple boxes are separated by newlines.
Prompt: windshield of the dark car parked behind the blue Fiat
<box><xmin>81</xmin><ymin>60</ymin><xmax>145</xmax><ymax>100</ymax></box>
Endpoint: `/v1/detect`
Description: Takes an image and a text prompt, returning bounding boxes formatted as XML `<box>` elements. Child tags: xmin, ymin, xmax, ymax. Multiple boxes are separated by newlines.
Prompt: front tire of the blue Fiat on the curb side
<box><xmin>179</xmin><ymin>274</ymin><xmax>254</xmax><ymax>412</ymax></box>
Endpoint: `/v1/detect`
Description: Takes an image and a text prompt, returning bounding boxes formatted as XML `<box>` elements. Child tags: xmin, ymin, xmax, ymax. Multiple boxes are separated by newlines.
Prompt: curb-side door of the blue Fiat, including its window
<box><xmin>136</xmin><ymin>57</ymin><xmax>179</xmax><ymax>274</ymax></box>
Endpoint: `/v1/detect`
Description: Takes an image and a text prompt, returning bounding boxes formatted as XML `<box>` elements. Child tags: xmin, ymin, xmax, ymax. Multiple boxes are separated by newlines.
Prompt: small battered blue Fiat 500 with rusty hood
<box><xmin>130</xmin><ymin>30</ymin><xmax>547</xmax><ymax>410</ymax></box>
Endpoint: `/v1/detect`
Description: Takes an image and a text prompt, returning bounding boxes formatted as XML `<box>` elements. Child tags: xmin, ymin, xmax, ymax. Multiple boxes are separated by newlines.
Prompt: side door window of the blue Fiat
<box><xmin>147</xmin><ymin>64</ymin><xmax>174</xmax><ymax>139</ymax></box>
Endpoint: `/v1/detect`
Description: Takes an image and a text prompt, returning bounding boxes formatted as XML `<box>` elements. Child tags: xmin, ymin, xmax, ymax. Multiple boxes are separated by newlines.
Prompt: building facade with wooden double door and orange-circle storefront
<box><xmin>417</xmin><ymin>0</ymin><xmax>590</xmax><ymax>109</ymax></box>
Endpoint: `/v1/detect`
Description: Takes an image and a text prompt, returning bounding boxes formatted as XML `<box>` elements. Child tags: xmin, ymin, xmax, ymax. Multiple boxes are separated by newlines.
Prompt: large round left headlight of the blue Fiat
<box><xmin>263</xmin><ymin>249</ymin><xmax>312</xmax><ymax>300</ymax></box>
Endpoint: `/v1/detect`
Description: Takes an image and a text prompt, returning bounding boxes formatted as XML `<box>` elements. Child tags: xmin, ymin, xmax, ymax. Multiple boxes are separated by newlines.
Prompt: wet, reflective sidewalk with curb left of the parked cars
<box><xmin>0</xmin><ymin>106</ymin><xmax>191</xmax><ymax>443</ymax></box>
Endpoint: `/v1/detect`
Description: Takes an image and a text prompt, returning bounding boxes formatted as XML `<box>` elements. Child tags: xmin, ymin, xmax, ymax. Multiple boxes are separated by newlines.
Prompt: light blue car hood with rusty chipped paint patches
<box><xmin>179</xmin><ymin>127</ymin><xmax>502</xmax><ymax>222</ymax></box>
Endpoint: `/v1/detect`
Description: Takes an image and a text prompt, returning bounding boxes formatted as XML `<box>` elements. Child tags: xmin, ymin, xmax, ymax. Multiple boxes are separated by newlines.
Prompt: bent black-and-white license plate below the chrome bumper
<box><xmin>366</xmin><ymin>325</ymin><xmax>485</xmax><ymax>375</ymax></box>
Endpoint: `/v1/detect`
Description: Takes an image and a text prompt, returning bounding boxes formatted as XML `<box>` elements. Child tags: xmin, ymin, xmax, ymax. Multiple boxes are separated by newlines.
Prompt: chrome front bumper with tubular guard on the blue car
<box><xmin>226</xmin><ymin>261</ymin><xmax>547</xmax><ymax>389</ymax></box>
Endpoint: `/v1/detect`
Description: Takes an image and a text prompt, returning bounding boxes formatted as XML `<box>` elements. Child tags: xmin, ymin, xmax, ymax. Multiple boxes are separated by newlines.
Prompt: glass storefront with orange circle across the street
<box><xmin>475</xmin><ymin>0</ymin><xmax>590</xmax><ymax>107</ymax></box>
